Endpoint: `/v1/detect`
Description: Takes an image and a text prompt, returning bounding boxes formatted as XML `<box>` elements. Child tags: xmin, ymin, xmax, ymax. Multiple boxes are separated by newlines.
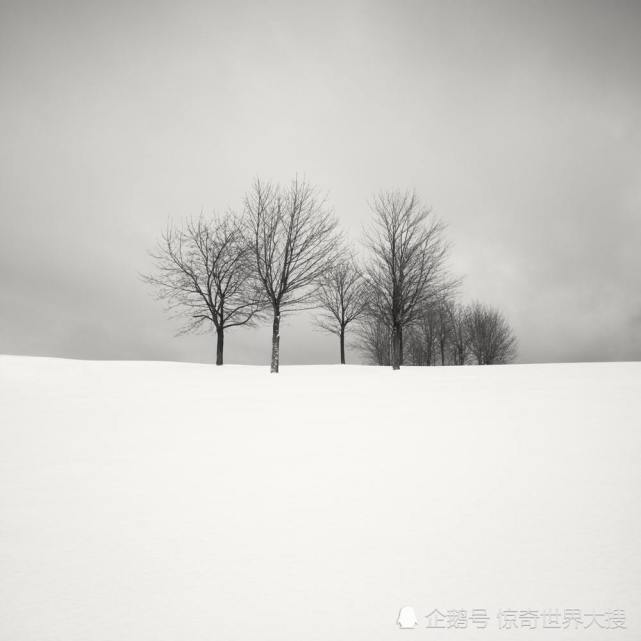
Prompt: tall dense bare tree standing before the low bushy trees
<box><xmin>365</xmin><ymin>192</ymin><xmax>454</xmax><ymax>369</ymax></box>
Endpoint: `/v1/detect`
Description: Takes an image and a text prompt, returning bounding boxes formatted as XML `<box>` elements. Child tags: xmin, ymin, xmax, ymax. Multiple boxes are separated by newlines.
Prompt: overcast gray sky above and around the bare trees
<box><xmin>0</xmin><ymin>0</ymin><xmax>641</xmax><ymax>363</ymax></box>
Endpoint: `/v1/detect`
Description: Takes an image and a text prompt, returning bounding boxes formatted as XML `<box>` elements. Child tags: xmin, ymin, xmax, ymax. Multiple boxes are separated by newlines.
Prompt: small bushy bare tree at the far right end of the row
<box><xmin>467</xmin><ymin>302</ymin><xmax>516</xmax><ymax>365</ymax></box>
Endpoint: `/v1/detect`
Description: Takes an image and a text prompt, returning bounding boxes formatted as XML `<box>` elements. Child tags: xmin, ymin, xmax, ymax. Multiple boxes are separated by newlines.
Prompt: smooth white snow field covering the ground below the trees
<box><xmin>0</xmin><ymin>356</ymin><xmax>641</xmax><ymax>641</ymax></box>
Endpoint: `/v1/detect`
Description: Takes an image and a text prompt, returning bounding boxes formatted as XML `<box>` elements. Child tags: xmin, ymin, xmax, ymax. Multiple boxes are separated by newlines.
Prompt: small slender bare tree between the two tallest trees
<box><xmin>316</xmin><ymin>252</ymin><xmax>367</xmax><ymax>365</ymax></box>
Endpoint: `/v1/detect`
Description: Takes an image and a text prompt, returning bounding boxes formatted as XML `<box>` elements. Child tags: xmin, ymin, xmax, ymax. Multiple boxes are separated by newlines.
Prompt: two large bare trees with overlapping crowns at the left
<box><xmin>143</xmin><ymin>179</ymin><xmax>340</xmax><ymax>372</ymax></box>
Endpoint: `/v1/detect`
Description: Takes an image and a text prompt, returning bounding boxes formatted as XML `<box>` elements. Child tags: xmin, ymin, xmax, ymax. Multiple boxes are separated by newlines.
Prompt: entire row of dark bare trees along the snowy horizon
<box><xmin>143</xmin><ymin>179</ymin><xmax>515</xmax><ymax>372</ymax></box>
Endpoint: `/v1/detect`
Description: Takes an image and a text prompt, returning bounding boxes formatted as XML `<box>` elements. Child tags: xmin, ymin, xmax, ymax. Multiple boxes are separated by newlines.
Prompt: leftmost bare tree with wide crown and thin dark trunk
<box><xmin>142</xmin><ymin>213</ymin><xmax>261</xmax><ymax>365</ymax></box>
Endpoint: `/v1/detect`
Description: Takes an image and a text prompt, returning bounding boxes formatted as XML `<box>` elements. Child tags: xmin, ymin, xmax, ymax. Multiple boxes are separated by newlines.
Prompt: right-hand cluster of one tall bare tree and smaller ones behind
<box><xmin>350</xmin><ymin>192</ymin><xmax>516</xmax><ymax>369</ymax></box>
